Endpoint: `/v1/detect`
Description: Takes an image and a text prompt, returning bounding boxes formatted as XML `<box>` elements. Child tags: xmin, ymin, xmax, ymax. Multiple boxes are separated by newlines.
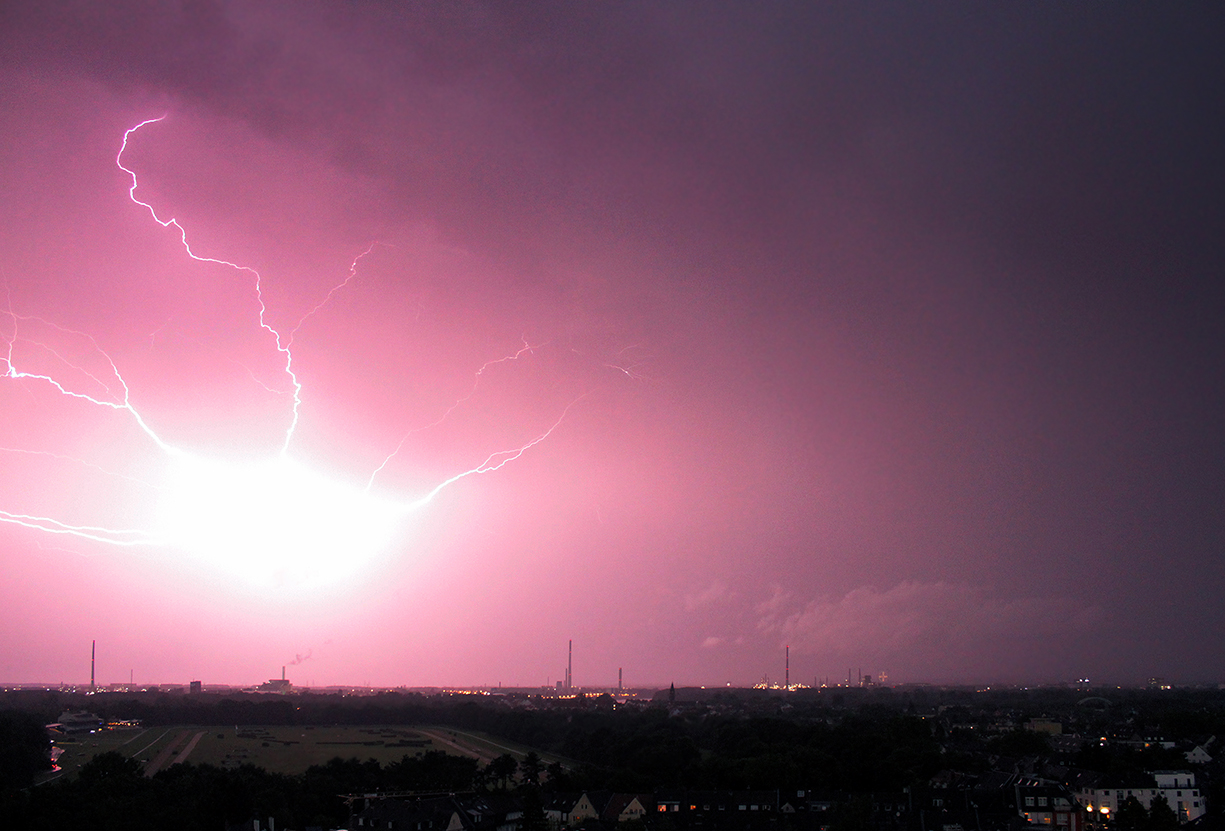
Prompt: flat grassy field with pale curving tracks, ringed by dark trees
<box><xmin>56</xmin><ymin>724</ymin><xmax>448</xmax><ymax>776</ymax></box>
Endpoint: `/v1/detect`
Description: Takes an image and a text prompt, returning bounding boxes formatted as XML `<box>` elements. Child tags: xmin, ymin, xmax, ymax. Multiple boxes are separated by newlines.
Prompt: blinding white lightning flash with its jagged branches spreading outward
<box><xmin>0</xmin><ymin>115</ymin><xmax>588</xmax><ymax>588</ymax></box>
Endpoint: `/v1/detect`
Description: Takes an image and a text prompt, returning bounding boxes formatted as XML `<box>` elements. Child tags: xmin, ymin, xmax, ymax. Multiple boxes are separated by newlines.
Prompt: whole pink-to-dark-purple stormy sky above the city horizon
<box><xmin>0</xmin><ymin>0</ymin><xmax>1225</xmax><ymax>686</ymax></box>
